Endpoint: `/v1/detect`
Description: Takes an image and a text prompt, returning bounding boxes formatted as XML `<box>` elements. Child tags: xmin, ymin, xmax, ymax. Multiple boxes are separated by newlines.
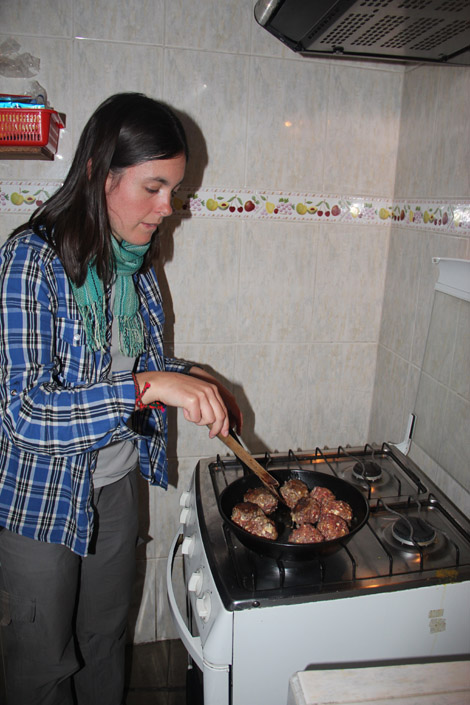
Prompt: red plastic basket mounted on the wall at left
<box><xmin>0</xmin><ymin>108</ymin><xmax>64</xmax><ymax>154</ymax></box>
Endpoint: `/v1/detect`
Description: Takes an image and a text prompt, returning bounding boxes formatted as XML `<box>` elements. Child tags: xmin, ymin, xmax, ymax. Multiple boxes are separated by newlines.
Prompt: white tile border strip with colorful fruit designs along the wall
<box><xmin>0</xmin><ymin>181</ymin><xmax>470</xmax><ymax>235</ymax></box>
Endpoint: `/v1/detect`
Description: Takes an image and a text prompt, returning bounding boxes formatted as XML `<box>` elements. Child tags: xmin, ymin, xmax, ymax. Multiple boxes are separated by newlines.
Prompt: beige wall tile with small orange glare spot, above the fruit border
<box><xmin>246</xmin><ymin>57</ymin><xmax>330</xmax><ymax>192</ymax></box>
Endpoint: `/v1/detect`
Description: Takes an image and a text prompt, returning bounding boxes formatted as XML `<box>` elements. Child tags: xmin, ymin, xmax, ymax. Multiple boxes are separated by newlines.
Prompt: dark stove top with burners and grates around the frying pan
<box><xmin>194</xmin><ymin>444</ymin><xmax>470</xmax><ymax>610</ymax></box>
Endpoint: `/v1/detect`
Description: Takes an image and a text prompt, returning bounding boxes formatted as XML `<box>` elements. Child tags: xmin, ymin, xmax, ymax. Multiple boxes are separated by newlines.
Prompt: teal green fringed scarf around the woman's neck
<box><xmin>71</xmin><ymin>237</ymin><xmax>150</xmax><ymax>357</ymax></box>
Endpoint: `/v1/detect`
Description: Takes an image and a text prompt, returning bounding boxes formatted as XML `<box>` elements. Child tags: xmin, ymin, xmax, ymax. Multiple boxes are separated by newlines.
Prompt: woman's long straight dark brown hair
<box><xmin>29</xmin><ymin>93</ymin><xmax>188</xmax><ymax>286</ymax></box>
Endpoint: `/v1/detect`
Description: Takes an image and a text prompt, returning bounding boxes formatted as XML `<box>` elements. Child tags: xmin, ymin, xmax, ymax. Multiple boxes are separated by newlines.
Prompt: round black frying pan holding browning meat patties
<box><xmin>219</xmin><ymin>470</ymin><xmax>369</xmax><ymax>561</ymax></box>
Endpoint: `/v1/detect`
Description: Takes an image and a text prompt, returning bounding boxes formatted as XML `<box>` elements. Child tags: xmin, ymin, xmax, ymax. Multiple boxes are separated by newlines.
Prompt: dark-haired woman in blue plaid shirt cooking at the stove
<box><xmin>0</xmin><ymin>93</ymin><xmax>241</xmax><ymax>705</ymax></box>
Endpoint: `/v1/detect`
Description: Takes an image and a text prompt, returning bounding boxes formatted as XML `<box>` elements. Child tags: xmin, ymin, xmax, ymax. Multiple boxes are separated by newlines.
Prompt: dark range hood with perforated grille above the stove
<box><xmin>254</xmin><ymin>0</ymin><xmax>470</xmax><ymax>66</ymax></box>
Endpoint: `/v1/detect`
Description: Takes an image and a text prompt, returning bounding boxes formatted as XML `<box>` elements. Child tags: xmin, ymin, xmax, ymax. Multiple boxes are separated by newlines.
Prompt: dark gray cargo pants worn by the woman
<box><xmin>0</xmin><ymin>472</ymin><xmax>138</xmax><ymax>705</ymax></box>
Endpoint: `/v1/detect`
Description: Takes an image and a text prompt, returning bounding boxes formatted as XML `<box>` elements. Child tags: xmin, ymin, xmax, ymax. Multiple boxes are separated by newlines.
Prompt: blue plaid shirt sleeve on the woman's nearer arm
<box><xmin>0</xmin><ymin>235</ymin><xmax>135</xmax><ymax>456</ymax></box>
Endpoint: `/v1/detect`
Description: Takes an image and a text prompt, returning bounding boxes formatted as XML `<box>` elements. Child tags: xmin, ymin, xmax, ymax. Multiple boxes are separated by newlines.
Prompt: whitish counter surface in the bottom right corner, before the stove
<box><xmin>287</xmin><ymin>661</ymin><xmax>470</xmax><ymax>705</ymax></box>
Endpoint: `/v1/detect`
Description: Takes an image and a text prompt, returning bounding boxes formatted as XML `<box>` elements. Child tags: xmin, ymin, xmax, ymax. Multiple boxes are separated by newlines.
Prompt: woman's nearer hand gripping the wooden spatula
<box><xmin>135</xmin><ymin>371</ymin><xmax>229</xmax><ymax>438</ymax></box>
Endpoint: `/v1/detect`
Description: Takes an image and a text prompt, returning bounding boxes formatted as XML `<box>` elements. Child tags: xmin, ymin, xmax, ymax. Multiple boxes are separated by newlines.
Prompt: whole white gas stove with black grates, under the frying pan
<box><xmin>167</xmin><ymin>443</ymin><xmax>470</xmax><ymax>705</ymax></box>
